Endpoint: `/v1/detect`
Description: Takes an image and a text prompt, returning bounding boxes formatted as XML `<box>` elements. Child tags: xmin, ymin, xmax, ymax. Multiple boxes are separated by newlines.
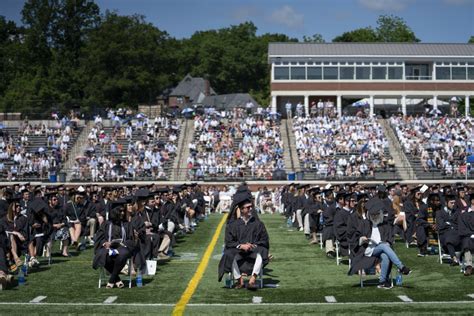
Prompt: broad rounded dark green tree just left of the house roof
<box><xmin>79</xmin><ymin>12</ymin><xmax>176</xmax><ymax>107</ymax></box>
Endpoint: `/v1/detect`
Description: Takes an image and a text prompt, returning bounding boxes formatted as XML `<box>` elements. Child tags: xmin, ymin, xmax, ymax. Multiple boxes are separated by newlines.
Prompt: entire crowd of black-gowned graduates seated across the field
<box><xmin>0</xmin><ymin>182</ymin><xmax>474</xmax><ymax>289</ymax></box>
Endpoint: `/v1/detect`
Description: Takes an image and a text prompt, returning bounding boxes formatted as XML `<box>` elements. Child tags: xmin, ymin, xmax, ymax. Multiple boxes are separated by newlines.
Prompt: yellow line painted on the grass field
<box><xmin>173</xmin><ymin>214</ymin><xmax>227</xmax><ymax>316</ymax></box>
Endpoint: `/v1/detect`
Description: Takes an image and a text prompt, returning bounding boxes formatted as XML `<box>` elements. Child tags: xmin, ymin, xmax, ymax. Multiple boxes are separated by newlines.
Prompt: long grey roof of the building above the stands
<box><xmin>268</xmin><ymin>43</ymin><xmax>474</xmax><ymax>58</ymax></box>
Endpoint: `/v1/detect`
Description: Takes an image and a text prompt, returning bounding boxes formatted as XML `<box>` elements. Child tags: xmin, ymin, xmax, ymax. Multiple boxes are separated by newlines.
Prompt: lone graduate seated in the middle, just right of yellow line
<box><xmin>219</xmin><ymin>192</ymin><xmax>270</xmax><ymax>289</ymax></box>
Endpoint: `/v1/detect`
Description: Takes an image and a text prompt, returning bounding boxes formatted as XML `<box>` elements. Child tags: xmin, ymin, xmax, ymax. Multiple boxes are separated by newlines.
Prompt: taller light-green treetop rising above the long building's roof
<box><xmin>376</xmin><ymin>15</ymin><xmax>420</xmax><ymax>43</ymax></box>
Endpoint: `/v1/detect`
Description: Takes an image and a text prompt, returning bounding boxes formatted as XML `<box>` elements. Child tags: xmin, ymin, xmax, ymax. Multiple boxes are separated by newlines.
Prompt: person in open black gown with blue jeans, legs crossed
<box><xmin>349</xmin><ymin>198</ymin><xmax>411</xmax><ymax>289</ymax></box>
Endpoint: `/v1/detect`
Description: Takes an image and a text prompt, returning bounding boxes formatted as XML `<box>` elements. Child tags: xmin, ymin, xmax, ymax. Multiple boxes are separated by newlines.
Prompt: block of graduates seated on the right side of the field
<box><xmin>281</xmin><ymin>182</ymin><xmax>474</xmax><ymax>289</ymax></box>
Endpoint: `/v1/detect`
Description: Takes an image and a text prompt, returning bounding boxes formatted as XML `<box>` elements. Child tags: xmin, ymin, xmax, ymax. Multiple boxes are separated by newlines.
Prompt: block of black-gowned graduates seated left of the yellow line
<box><xmin>0</xmin><ymin>184</ymin><xmax>215</xmax><ymax>288</ymax></box>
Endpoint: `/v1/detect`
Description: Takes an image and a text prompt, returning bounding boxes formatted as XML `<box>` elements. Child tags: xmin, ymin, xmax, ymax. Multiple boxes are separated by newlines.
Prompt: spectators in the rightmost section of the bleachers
<box><xmin>390</xmin><ymin>116</ymin><xmax>474</xmax><ymax>177</ymax></box>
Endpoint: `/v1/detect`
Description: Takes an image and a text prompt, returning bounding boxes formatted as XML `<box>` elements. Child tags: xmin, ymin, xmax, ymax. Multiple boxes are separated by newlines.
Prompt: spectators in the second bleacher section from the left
<box><xmin>73</xmin><ymin>111</ymin><xmax>181</xmax><ymax>181</ymax></box>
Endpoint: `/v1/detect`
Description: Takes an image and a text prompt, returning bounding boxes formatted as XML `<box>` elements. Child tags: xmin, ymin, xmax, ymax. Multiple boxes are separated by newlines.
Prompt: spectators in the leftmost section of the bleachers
<box><xmin>0</xmin><ymin>112</ymin><xmax>78</xmax><ymax>181</ymax></box>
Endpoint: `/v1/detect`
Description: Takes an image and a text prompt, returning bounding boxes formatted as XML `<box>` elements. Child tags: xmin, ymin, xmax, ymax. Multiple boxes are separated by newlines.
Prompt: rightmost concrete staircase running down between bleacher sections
<box><xmin>378</xmin><ymin>119</ymin><xmax>417</xmax><ymax>180</ymax></box>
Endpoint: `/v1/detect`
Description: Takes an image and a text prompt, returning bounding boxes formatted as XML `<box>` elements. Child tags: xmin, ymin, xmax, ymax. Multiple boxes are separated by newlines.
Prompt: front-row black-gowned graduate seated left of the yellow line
<box><xmin>92</xmin><ymin>206</ymin><xmax>138</xmax><ymax>288</ymax></box>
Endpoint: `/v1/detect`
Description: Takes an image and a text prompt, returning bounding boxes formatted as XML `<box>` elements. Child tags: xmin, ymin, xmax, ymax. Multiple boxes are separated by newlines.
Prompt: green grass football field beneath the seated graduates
<box><xmin>0</xmin><ymin>215</ymin><xmax>474</xmax><ymax>315</ymax></box>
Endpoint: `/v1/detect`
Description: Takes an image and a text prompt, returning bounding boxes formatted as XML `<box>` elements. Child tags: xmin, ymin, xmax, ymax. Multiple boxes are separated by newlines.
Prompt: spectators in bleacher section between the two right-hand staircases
<box><xmin>293</xmin><ymin>116</ymin><xmax>395</xmax><ymax>178</ymax></box>
